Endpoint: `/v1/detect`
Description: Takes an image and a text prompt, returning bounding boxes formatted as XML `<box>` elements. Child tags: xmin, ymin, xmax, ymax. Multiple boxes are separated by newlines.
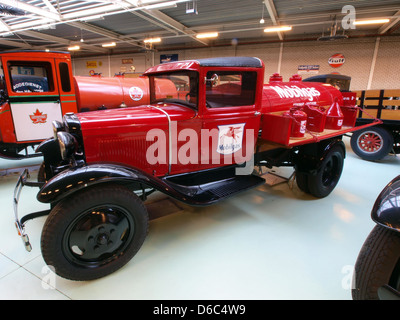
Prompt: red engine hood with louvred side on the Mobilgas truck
<box><xmin>77</xmin><ymin>104</ymin><xmax>197</xmax><ymax>175</ymax></box>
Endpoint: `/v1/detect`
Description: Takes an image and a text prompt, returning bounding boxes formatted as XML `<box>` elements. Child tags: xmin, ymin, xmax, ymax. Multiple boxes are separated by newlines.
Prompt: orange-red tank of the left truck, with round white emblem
<box><xmin>74</xmin><ymin>76</ymin><xmax>150</xmax><ymax>112</ymax></box>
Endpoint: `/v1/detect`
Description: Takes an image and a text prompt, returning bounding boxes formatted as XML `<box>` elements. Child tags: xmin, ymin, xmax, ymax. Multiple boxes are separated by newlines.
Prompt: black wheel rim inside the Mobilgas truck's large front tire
<box><xmin>63</xmin><ymin>205</ymin><xmax>135</xmax><ymax>267</ymax></box>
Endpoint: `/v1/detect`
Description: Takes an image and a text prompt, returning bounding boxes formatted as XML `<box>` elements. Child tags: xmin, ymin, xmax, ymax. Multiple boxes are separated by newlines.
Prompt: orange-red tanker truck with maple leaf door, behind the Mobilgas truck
<box><xmin>0</xmin><ymin>51</ymin><xmax>153</xmax><ymax>159</ymax></box>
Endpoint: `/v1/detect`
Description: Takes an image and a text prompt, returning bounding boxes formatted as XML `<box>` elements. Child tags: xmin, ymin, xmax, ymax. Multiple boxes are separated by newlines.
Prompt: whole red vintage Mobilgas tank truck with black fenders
<box><xmin>14</xmin><ymin>57</ymin><xmax>380</xmax><ymax>280</ymax></box>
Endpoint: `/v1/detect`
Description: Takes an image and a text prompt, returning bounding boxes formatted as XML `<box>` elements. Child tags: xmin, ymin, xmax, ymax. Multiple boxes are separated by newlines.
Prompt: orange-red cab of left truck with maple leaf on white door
<box><xmin>0</xmin><ymin>52</ymin><xmax>77</xmax><ymax>157</ymax></box>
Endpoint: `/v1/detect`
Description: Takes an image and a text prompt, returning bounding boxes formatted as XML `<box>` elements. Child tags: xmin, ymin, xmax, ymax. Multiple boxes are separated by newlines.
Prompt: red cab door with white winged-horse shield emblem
<box><xmin>201</xmin><ymin>68</ymin><xmax>262</xmax><ymax>169</ymax></box>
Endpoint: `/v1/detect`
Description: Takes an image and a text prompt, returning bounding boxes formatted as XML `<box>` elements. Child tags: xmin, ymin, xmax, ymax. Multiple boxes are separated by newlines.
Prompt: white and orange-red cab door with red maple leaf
<box><xmin>3</xmin><ymin>56</ymin><xmax>62</xmax><ymax>142</ymax></box>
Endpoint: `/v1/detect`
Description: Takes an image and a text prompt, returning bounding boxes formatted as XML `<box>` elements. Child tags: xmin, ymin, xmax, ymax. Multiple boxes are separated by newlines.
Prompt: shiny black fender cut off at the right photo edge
<box><xmin>371</xmin><ymin>176</ymin><xmax>400</xmax><ymax>231</ymax></box>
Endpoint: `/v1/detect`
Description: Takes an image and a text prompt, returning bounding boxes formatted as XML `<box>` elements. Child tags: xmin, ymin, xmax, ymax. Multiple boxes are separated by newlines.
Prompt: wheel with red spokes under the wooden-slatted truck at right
<box><xmin>350</xmin><ymin>127</ymin><xmax>393</xmax><ymax>161</ymax></box>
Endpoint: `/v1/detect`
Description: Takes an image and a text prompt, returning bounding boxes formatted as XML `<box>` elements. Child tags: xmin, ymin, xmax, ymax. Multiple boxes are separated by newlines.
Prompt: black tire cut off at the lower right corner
<box><xmin>352</xmin><ymin>225</ymin><xmax>400</xmax><ymax>300</ymax></box>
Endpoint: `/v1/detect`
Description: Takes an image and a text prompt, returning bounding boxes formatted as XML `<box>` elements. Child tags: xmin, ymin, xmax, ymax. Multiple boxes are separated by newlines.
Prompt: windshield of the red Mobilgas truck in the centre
<box><xmin>151</xmin><ymin>71</ymin><xmax>199</xmax><ymax>109</ymax></box>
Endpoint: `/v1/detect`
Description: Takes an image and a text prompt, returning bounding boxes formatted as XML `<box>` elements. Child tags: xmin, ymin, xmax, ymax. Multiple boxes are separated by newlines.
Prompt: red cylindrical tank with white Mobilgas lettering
<box><xmin>261</xmin><ymin>74</ymin><xmax>343</xmax><ymax>113</ymax></box>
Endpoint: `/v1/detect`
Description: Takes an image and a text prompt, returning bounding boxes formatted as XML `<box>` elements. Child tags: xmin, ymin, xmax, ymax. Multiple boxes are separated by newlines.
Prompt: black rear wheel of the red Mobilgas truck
<box><xmin>307</xmin><ymin>145</ymin><xmax>344</xmax><ymax>198</ymax></box>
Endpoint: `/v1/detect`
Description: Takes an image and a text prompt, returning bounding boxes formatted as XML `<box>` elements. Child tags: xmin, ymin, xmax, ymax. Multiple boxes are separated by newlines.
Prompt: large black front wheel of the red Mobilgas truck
<box><xmin>41</xmin><ymin>184</ymin><xmax>149</xmax><ymax>280</ymax></box>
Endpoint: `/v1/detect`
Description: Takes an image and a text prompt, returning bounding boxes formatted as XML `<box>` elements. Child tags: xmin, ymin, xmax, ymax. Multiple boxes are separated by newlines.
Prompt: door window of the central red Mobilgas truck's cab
<box><xmin>206</xmin><ymin>71</ymin><xmax>257</xmax><ymax>108</ymax></box>
